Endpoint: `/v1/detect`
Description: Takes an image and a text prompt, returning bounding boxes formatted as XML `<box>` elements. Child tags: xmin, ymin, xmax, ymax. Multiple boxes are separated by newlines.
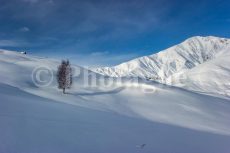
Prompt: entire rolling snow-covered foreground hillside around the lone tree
<box><xmin>0</xmin><ymin>51</ymin><xmax>230</xmax><ymax>153</ymax></box>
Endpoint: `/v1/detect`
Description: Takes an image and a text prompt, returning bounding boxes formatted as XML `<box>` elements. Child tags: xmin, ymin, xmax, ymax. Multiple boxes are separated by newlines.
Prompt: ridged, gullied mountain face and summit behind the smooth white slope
<box><xmin>95</xmin><ymin>36</ymin><xmax>230</xmax><ymax>82</ymax></box>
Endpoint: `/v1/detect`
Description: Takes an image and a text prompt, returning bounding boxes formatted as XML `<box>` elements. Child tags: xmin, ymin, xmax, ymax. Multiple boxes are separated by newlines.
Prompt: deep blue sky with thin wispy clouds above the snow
<box><xmin>0</xmin><ymin>0</ymin><xmax>230</xmax><ymax>66</ymax></box>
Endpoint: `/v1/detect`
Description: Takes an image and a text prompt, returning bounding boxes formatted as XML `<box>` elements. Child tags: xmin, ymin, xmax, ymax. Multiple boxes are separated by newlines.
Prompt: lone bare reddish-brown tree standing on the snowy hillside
<box><xmin>57</xmin><ymin>60</ymin><xmax>72</xmax><ymax>94</ymax></box>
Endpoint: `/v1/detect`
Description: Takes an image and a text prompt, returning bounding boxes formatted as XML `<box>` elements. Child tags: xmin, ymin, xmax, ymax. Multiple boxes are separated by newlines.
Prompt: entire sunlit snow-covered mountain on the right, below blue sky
<box><xmin>95</xmin><ymin>36</ymin><xmax>230</xmax><ymax>94</ymax></box>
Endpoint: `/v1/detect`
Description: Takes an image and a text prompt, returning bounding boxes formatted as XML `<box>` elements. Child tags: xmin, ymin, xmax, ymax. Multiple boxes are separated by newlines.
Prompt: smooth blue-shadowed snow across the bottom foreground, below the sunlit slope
<box><xmin>0</xmin><ymin>84</ymin><xmax>230</xmax><ymax>153</ymax></box>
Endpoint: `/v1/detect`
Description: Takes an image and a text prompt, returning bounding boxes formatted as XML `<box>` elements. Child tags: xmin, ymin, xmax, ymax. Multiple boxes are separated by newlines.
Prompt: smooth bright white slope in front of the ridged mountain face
<box><xmin>166</xmin><ymin>49</ymin><xmax>230</xmax><ymax>97</ymax></box>
